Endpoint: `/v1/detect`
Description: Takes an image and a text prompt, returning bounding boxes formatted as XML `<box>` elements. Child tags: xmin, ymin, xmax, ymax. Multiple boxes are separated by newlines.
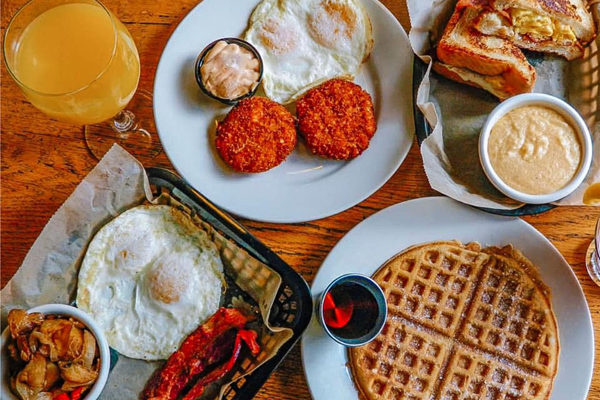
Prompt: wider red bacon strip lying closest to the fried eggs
<box><xmin>142</xmin><ymin>307</ymin><xmax>255</xmax><ymax>400</ymax></box>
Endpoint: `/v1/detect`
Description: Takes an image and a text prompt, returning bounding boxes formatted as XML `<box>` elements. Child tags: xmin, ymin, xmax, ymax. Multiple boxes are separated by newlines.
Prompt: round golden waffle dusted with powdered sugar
<box><xmin>349</xmin><ymin>242</ymin><xmax>559</xmax><ymax>400</ymax></box>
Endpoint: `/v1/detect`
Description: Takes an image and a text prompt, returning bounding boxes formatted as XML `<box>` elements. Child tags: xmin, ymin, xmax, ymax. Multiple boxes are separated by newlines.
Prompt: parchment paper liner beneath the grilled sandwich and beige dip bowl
<box><xmin>407</xmin><ymin>0</ymin><xmax>600</xmax><ymax>209</ymax></box>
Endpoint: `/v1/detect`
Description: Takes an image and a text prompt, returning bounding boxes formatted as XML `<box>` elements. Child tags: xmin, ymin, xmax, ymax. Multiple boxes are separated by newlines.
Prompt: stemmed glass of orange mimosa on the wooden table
<box><xmin>3</xmin><ymin>0</ymin><xmax>151</xmax><ymax>158</ymax></box>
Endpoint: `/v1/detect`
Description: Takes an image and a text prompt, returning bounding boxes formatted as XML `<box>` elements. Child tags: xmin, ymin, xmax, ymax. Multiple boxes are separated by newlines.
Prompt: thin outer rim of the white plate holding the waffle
<box><xmin>300</xmin><ymin>196</ymin><xmax>596</xmax><ymax>400</ymax></box>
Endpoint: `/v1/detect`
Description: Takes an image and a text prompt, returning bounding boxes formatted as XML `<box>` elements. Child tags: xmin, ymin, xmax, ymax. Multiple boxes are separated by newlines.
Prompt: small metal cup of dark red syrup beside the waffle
<box><xmin>317</xmin><ymin>274</ymin><xmax>387</xmax><ymax>347</ymax></box>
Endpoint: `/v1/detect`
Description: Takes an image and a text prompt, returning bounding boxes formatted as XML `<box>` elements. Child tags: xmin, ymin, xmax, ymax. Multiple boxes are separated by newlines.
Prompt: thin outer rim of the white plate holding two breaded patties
<box><xmin>152</xmin><ymin>0</ymin><xmax>416</xmax><ymax>224</ymax></box>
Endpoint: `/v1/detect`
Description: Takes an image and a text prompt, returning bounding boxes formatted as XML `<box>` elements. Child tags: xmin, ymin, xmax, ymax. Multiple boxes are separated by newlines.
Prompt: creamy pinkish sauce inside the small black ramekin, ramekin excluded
<box><xmin>200</xmin><ymin>40</ymin><xmax>260</xmax><ymax>99</ymax></box>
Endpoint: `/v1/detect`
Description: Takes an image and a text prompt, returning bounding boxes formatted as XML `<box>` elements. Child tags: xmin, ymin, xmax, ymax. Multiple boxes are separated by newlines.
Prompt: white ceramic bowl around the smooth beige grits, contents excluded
<box><xmin>479</xmin><ymin>93</ymin><xmax>592</xmax><ymax>204</ymax></box>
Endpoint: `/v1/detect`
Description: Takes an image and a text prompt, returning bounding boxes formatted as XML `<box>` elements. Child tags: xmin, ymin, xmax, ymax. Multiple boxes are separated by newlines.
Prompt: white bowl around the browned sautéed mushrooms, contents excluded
<box><xmin>0</xmin><ymin>304</ymin><xmax>110</xmax><ymax>400</ymax></box>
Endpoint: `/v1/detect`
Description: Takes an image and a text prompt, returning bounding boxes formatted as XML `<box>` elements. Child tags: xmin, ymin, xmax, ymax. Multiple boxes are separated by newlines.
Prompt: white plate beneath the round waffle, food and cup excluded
<box><xmin>302</xmin><ymin>197</ymin><xmax>594</xmax><ymax>400</ymax></box>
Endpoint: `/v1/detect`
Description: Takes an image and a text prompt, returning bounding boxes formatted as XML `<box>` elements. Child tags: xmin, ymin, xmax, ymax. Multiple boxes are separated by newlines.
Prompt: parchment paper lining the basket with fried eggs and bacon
<box><xmin>0</xmin><ymin>145</ymin><xmax>293</xmax><ymax>400</ymax></box>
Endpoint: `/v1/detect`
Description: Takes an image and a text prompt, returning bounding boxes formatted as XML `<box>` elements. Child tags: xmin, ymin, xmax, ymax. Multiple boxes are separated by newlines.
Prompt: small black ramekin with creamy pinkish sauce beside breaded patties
<box><xmin>194</xmin><ymin>38</ymin><xmax>263</xmax><ymax>105</ymax></box>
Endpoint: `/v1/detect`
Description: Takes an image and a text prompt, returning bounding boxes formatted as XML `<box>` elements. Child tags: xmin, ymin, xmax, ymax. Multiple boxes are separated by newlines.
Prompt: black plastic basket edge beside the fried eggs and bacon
<box><xmin>146</xmin><ymin>168</ymin><xmax>312</xmax><ymax>400</ymax></box>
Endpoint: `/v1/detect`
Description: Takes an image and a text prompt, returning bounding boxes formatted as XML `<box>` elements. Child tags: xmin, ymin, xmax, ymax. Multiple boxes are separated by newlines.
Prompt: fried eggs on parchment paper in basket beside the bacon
<box><xmin>77</xmin><ymin>205</ymin><xmax>223</xmax><ymax>360</ymax></box>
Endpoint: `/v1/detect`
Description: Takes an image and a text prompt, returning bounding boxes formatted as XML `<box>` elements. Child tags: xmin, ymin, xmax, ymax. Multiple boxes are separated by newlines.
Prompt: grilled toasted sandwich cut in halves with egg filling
<box><xmin>433</xmin><ymin>0</ymin><xmax>596</xmax><ymax>100</ymax></box>
